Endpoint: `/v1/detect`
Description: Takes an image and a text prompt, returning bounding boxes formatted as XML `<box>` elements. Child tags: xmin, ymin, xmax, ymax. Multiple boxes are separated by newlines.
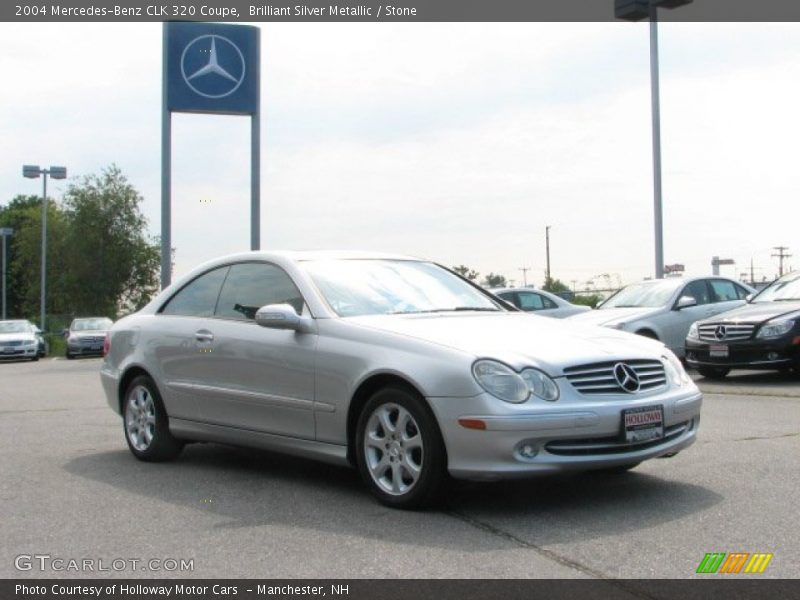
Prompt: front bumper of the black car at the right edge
<box><xmin>686</xmin><ymin>335</ymin><xmax>800</xmax><ymax>369</ymax></box>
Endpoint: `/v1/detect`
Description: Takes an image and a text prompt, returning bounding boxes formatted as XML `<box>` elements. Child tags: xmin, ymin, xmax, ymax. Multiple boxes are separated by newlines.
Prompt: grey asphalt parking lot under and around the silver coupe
<box><xmin>0</xmin><ymin>359</ymin><xmax>800</xmax><ymax>578</ymax></box>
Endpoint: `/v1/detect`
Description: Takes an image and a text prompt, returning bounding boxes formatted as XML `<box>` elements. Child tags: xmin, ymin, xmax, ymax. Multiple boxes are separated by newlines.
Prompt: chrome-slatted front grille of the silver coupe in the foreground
<box><xmin>564</xmin><ymin>359</ymin><xmax>667</xmax><ymax>395</ymax></box>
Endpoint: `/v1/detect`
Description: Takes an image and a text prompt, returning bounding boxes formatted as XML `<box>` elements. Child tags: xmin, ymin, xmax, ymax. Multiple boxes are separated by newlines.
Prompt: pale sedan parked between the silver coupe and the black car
<box><xmin>570</xmin><ymin>277</ymin><xmax>754</xmax><ymax>357</ymax></box>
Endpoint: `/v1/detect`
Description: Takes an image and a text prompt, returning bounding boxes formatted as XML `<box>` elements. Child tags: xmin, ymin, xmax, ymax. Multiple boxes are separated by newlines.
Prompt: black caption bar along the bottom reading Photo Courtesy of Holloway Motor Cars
<box><xmin>0</xmin><ymin>578</ymin><xmax>800</xmax><ymax>600</ymax></box>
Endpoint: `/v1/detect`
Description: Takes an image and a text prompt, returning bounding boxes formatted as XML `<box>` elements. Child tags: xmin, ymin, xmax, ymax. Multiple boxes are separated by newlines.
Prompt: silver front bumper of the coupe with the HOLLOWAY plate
<box><xmin>429</xmin><ymin>385</ymin><xmax>703</xmax><ymax>480</ymax></box>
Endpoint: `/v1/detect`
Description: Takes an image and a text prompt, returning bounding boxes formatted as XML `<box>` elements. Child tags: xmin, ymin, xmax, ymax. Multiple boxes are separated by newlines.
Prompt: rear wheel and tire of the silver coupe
<box><xmin>122</xmin><ymin>375</ymin><xmax>183</xmax><ymax>462</ymax></box>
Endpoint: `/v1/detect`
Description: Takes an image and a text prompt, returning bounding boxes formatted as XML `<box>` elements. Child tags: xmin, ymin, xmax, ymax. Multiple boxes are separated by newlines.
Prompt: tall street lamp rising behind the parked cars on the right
<box><xmin>614</xmin><ymin>0</ymin><xmax>693</xmax><ymax>279</ymax></box>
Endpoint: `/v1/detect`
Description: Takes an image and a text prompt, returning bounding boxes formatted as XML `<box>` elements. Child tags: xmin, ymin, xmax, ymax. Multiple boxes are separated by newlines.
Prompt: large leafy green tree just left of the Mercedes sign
<box><xmin>64</xmin><ymin>165</ymin><xmax>160</xmax><ymax>317</ymax></box>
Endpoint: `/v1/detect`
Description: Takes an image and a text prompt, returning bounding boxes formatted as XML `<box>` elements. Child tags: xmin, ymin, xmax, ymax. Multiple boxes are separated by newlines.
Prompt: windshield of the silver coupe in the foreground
<box><xmin>303</xmin><ymin>259</ymin><xmax>505</xmax><ymax>317</ymax></box>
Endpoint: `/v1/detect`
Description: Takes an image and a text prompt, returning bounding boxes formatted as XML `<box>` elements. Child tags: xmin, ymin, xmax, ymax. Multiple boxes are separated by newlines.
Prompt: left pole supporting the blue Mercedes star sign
<box><xmin>161</xmin><ymin>23</ymin><xmax>172</xmax><ymax>290</ymax></box>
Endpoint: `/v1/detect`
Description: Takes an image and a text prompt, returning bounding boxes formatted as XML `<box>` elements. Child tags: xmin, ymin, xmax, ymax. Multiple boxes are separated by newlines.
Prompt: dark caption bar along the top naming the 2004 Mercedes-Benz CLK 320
<box><xmin>0</xmin><ymin>0</ymin><xmax>800</xmax><ymax>23</ymax></box>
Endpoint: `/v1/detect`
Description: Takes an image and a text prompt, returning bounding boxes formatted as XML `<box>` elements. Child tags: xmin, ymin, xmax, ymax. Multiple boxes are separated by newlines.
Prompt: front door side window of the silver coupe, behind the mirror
<box><xmin>216</xmin><ymin>263</ymin><xmax>303</xmax><ymax>320</ymax></box>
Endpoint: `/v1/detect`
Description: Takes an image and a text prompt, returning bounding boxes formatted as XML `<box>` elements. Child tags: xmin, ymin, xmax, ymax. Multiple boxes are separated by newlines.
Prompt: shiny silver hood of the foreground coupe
<box><xmin>347</xmin><ymin>313</ymin><xmax>664</xmax><ymax>376</ymax></box>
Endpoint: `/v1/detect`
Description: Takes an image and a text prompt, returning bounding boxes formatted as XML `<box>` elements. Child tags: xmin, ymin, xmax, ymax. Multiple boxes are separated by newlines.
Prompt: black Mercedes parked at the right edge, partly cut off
<box><xmin>686</xmin><ymin>271</ymin><xmax>800</xmax><ymax>378</ymax></box>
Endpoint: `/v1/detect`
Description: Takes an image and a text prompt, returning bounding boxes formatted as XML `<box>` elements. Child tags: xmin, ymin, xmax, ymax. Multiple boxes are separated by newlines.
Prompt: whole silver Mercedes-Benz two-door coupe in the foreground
<box><xmin>101</xmin><ymin>252</ymin><xmax>702</xmax><ymax>507</ymax></box>
